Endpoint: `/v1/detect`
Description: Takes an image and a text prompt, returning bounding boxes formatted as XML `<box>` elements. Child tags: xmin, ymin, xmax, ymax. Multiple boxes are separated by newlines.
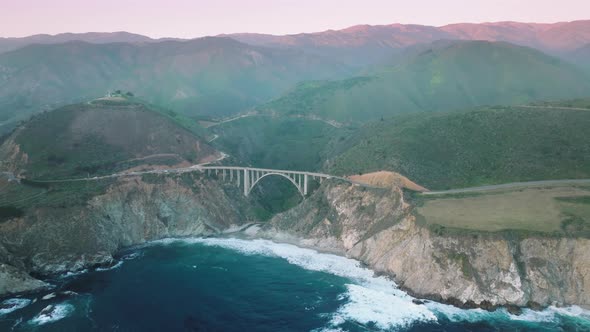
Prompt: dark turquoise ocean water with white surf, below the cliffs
<box><xmin>0</xmin><ymin>239</ymin><xmax>590</xmax><ymax>332</ymax></box>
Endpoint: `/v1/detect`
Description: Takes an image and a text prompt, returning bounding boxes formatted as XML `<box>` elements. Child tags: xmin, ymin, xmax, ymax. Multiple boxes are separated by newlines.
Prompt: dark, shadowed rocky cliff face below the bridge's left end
<box><xmin>0</xmin><ymin>176</ymin><xmax>249</xmax><ymax>294</ymax></box>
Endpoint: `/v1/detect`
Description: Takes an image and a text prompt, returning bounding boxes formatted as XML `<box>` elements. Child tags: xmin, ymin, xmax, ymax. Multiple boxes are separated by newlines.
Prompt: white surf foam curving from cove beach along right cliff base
<box><xmin>149</xmin><ymin>238</ymin><xmax>590</xmax><ymax>331</ymax></box>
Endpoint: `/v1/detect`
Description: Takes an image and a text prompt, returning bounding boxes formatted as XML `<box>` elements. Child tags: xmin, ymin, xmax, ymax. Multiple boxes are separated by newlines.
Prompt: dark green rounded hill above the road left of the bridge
<box><xmin>0</xmin><ymin>99</ymin><xmax>217</xmax><ymax>179</ymax></box>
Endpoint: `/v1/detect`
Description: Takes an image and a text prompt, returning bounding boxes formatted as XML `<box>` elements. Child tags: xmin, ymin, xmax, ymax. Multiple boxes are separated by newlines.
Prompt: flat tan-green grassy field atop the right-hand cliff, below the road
<box><xmin>416</xmin><ymin>186</ymin><xmax>590</xmax><ymax>237</ymax></box>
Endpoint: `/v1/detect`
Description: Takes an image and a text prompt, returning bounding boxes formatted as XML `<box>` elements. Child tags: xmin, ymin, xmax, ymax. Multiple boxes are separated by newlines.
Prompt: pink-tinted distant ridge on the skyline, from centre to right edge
<box><xmin>227</xmin><ymin>20</ymin><xmax>590</xmax><ymax>58</ymax></box>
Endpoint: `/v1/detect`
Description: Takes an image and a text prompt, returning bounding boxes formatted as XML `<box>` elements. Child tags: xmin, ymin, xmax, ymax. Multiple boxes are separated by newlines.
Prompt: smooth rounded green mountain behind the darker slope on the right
<box><xmin>259</xmin><ymin>41</ymin><xmax>590</xmax><ymax>122</ymax></box>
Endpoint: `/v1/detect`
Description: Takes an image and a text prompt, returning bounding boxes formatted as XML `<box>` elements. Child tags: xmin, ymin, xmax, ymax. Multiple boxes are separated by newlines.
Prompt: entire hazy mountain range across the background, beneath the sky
<box><xmin>0</xmin><ymin>20</ymin><xmax>590</xmax><ymax>133</ymax></box>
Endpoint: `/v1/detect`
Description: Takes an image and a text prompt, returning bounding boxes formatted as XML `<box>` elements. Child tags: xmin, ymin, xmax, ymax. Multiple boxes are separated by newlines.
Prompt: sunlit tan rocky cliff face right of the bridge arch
<box><xmin>266</xmin><ymin>185</ymin><xmax>590</xmax><ymax>307</ymax></box>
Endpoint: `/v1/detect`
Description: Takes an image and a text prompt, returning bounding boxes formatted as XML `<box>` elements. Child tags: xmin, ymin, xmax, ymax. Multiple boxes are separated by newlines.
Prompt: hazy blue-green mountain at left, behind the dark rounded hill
<box><xmin>0</xmin><ymin>37</ymin><xmax>348</xmax><ymax>129</ymax></box>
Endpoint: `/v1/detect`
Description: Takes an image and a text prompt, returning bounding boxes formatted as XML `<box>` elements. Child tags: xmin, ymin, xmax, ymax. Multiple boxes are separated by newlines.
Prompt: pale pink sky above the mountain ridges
<box><xmin>0</xmin><ymin>0</ymin><xmax>590</xmax><ymax>38</ymax></box>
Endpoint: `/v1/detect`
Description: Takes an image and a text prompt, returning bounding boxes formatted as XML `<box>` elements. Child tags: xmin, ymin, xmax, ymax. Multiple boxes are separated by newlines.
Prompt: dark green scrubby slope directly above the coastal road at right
<box><xmin>327</xmin><ymin>107</ymin><xmax>590</xmax><ymax>189</ymax></box>
